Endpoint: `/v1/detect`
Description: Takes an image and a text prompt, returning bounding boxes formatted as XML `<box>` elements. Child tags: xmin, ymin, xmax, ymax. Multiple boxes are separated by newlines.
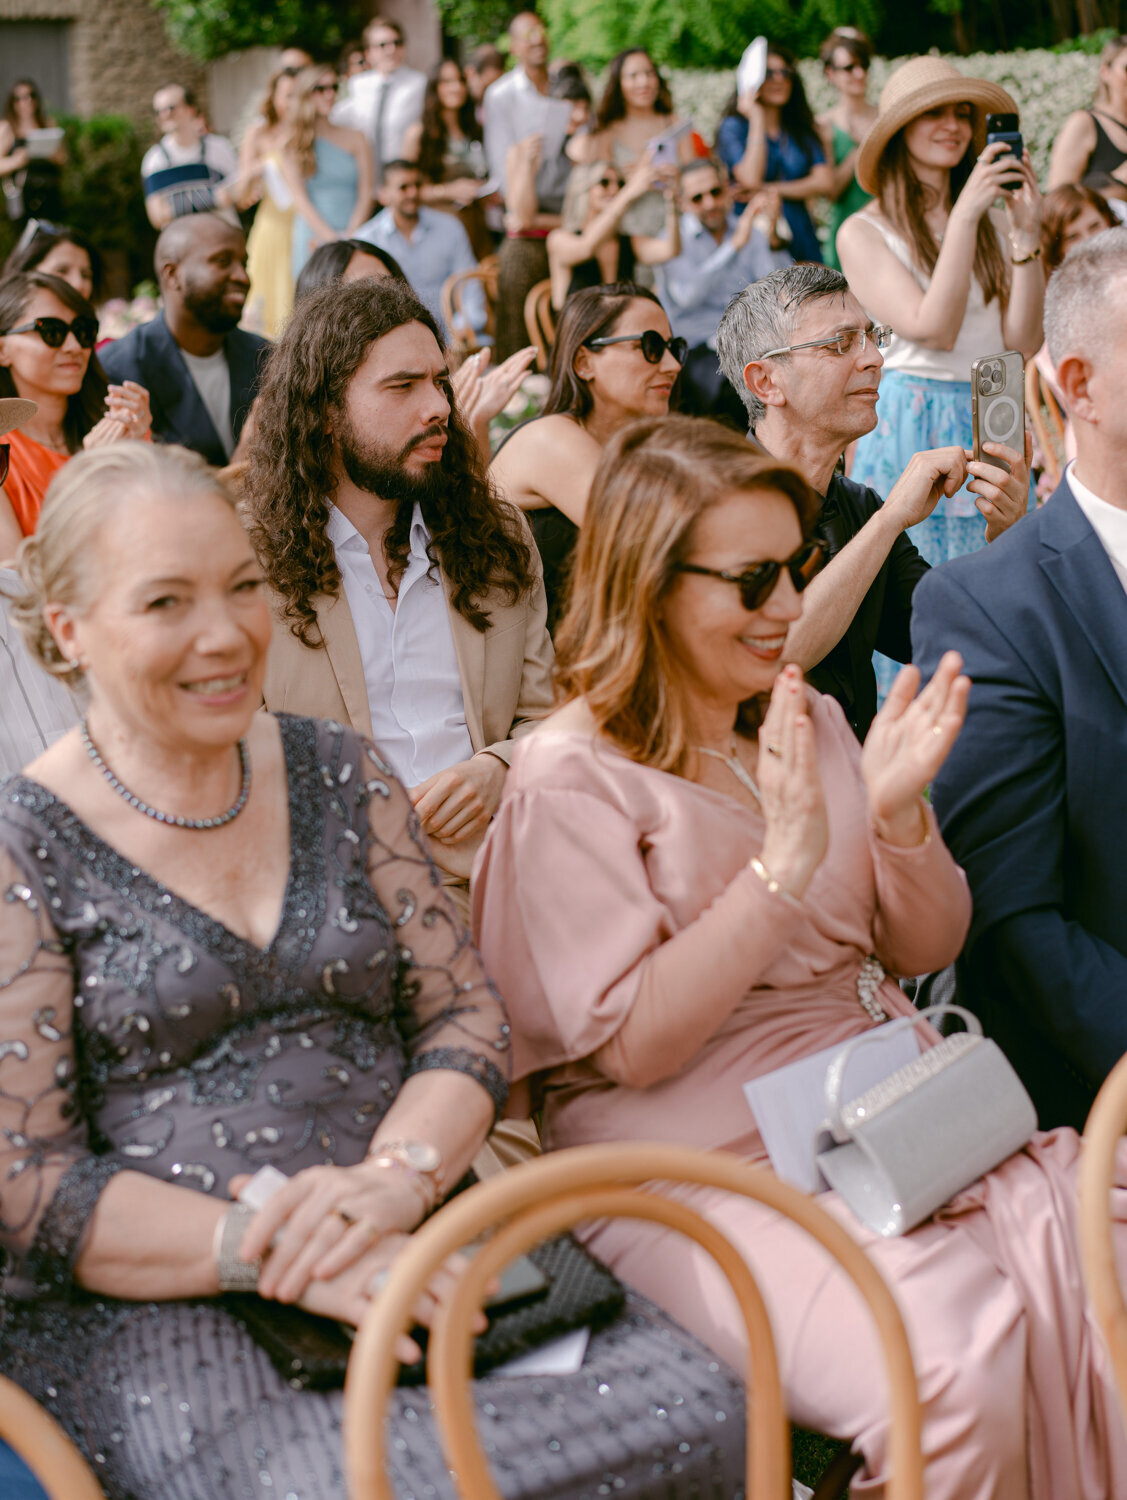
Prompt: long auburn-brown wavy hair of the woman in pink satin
<box><xmin>555</xmin><ymin>417</ymin><xmax>819</xmax><ymax>776</ymax></box>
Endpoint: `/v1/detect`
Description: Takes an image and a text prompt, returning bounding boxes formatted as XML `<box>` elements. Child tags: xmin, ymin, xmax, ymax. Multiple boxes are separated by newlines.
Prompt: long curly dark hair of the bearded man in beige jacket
<box><xmin>245</xmin><ymin>276</ymin><xmax>536</xmax><ymax>647</ymax></box>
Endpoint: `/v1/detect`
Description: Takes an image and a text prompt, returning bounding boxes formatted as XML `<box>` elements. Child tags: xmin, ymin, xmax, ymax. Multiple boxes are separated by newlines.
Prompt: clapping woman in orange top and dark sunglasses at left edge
<box><xmin>0</xmin><ymin>272</ymin><xmax>152</xmax><ymax>563</ymax></box>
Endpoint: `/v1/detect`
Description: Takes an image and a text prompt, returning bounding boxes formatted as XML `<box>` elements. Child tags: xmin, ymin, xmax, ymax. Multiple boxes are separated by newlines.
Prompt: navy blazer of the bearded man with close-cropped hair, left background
<box><xmin>98</xmin><ymin>312</ymin><xmax>270</xmax><ymax>468</ymax></box>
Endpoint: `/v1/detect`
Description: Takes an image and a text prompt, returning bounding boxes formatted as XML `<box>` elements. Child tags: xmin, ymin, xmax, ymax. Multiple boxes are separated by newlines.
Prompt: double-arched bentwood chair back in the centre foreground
<box><xmin>344</xmin><ymin>1145</ymin><xmax>924</xmax><ymax>1500</ymax></box>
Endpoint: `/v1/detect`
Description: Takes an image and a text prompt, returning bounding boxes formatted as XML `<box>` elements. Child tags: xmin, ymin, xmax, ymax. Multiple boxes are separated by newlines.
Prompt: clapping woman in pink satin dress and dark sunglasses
<box><xmin>473</xmin><ymin>419</ymin><xmax>1127</xmax><ymax>1500</ymax></box>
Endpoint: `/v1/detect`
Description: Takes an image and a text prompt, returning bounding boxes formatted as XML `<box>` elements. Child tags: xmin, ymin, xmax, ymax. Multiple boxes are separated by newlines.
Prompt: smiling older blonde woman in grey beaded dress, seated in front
<box><xmin>0</xmin><ymin>444</ymin><xmax>741</xmax><ymax>1500</ymax></box>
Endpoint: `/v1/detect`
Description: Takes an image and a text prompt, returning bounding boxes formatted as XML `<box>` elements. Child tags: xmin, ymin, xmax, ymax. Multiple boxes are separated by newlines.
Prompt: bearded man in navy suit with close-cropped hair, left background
<box><xmin>99</xmin><ymin>213</ymin><xmax>269</xmax><ymax>468</ymax></box>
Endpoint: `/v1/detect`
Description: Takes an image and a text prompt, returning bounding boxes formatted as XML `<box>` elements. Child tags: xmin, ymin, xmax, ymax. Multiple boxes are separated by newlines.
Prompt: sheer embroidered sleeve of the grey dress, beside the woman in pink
<box><xmin>325</xmin><ymin>735</ymin><xmax>512</xmax><ymax>1113</ymax></box>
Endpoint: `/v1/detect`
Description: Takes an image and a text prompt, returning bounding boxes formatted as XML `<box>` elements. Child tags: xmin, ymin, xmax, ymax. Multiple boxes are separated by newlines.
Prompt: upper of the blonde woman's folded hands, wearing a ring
<box><xmin>230</xmin><ymin>1161</ymin><xmax>423</xmax><ymax>1302</ymax></box>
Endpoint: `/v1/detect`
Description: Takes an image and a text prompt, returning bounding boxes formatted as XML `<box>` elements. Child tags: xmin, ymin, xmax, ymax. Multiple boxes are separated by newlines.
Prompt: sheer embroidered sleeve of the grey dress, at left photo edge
<box><xmin>0</xmin><ymin>822</ymin><xmax>120</xmax><ymax>1296</ymax></box>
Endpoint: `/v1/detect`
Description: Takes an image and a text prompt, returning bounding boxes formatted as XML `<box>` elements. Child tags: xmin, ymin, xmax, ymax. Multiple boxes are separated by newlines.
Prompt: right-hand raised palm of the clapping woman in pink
<box><xmin>861</xmin><ymin>651</ymin><xmax>971</xmax><ymax>849</ymax></box>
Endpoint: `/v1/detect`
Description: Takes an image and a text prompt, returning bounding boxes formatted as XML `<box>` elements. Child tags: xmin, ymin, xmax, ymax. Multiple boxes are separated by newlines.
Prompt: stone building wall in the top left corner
<box><xmin>0</xmin><ymin>0</ymin><xmax>207</xmax><ymax>124</ymax></box>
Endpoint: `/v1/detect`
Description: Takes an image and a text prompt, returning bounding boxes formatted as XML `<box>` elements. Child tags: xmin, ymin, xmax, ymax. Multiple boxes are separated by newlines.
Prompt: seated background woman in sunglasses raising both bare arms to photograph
<box><xmin>548</xmin><ymin>152</ymin><xmax>681</xmax><ymax>312</ymax></box>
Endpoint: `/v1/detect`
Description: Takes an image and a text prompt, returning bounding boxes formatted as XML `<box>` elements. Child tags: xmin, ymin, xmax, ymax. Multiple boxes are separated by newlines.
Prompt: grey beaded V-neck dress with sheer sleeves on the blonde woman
<box><xmin>0</xmin><ymin>716</ymin><xmax>743</xmax><ymax>1500</ymax></box>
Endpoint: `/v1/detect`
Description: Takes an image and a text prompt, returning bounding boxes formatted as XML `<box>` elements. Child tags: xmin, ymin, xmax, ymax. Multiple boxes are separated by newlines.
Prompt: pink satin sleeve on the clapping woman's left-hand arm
<box><xmin>474</xmin><ymin>788</ymin><xmax>804</xmax><ymax>1079</ymax></box>
